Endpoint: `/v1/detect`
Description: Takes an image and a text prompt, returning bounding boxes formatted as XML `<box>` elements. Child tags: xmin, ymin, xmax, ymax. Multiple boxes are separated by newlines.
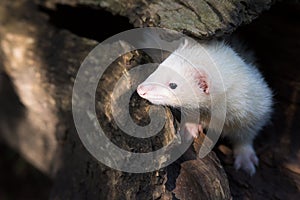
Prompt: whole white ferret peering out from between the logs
<box><xmin>137</xmin><ymin>40</ymin><xmax>272</xmax><ymax>175</ymax></box>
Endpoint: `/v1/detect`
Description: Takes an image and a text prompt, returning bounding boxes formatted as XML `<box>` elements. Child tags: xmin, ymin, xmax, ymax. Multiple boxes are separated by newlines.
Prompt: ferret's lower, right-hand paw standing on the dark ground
<box><xmin>234</xmin><ymin>145</ymin><xmax>259</xmax><ymax>176</ymax></box>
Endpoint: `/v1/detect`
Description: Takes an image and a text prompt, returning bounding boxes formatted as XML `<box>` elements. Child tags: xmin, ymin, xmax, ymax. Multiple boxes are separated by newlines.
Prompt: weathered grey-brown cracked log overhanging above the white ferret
<box><xmin>42</xmin><ymin>0</ymin><xmax>275</xmax><ymax>39</ymax></box>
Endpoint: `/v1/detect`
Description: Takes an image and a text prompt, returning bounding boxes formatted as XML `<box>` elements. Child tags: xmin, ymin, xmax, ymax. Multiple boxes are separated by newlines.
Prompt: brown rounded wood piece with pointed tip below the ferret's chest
<box><xmin>173</xmin><ymin>133</ymin><xmax>231</xmax><ymax>200</ymax></box>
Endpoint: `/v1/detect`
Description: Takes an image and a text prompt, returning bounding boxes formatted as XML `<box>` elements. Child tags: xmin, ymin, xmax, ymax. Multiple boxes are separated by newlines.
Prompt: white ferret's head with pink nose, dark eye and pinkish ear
<box><xmin>137</xmin><ymin>47</ymin><xmax>210</xmax><ymax>108</ymax></box>
